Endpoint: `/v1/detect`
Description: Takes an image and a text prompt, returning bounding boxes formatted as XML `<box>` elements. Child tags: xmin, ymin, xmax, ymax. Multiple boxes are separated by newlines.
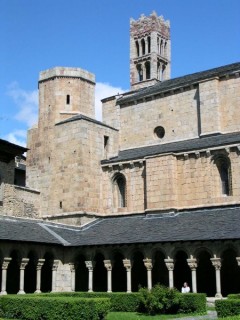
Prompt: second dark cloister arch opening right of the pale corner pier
<box><xmin>93</xmin><ymin>252</ymin><xmax>107</xmax><ymax>292</ymax></box>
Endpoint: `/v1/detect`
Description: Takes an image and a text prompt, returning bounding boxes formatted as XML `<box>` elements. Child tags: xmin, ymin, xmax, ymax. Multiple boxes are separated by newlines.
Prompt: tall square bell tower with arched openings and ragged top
<box><xmin>130</xmin><ymin>12</ymin><xmax>171</xmax><ymax>89</ymax></box>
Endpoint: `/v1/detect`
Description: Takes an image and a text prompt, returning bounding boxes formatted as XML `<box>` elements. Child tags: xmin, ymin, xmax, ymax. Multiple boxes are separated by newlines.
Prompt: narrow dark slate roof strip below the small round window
<box><xmin>101</xmin><ymin>132</ymin><xmax>240</xmax><ymax>164</ymax></box>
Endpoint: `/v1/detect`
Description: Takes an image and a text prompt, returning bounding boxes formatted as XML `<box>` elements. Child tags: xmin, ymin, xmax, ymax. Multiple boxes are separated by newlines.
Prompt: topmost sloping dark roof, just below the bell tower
<box><xmin>117</xmin><ymin>62</ymin><xmax>240</xmax><ymax>105</ymax></box>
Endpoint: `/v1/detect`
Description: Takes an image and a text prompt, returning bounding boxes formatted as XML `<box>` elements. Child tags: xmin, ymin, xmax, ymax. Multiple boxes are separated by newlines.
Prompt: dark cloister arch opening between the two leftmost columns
<box><xmin>6</xmin><ymin>250</ymin><xmax>21</xmax><ymax>294</ymax></box>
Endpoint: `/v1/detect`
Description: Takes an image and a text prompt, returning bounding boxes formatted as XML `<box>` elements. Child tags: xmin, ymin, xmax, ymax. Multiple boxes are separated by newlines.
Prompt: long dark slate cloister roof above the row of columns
<box><xmin>0</xmin><ymin>207</ymin><xmax>240</xmax><ymax>246</ymax></box>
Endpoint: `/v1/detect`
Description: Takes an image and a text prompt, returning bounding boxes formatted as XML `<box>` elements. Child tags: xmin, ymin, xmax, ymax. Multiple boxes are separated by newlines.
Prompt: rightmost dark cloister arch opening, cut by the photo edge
<box><xmin>221</xmin><ymin>247</ymin><xmax>240</xmax><ymax>297</ymax></box>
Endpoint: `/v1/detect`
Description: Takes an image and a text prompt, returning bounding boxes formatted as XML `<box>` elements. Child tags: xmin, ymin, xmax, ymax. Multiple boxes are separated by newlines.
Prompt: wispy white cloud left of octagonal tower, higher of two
<box><xmin>7</xmin><ymin>82</ymin><xmax>38</xmax><ymax>127</ymax></box>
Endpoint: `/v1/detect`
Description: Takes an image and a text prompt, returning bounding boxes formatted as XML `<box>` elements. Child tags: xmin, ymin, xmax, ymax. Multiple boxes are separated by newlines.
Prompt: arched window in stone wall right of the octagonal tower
<box><xmin>113</xmin><ymin>173</ymin><xmax>127</xmax><ymax>208</ymax></box>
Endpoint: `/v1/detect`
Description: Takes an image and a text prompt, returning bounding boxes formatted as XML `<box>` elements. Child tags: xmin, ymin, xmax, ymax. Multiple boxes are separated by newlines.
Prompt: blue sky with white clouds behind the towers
<box><xmin>0</xmin><ymin>0</ymin><xmax>240</xmax><ymax>145</ymax></box>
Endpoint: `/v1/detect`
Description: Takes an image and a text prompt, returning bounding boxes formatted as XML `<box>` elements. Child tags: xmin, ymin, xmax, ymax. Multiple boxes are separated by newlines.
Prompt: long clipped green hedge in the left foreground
<box><xmin>0</xmin><ymin>295</ymin><xmax>110</xmax><ymax>320</ymax></box>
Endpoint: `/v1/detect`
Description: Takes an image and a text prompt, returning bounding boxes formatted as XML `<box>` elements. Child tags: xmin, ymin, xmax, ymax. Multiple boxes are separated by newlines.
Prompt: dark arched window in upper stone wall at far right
<box><xmin>214</xmin><ymin>155</ymin><xmax>232</xmax><ymax>196</ymax></box>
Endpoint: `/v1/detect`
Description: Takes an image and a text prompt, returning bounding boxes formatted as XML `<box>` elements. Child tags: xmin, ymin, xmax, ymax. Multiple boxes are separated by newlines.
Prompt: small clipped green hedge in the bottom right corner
<box><xmin>215</xmin><ymin>298</ymin><xmax>240</xmax><ymax>318</ymax></box>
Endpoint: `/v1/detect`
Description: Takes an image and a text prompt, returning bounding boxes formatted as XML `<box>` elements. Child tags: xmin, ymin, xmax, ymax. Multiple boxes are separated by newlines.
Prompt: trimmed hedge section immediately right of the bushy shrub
<box><xmin>178</xmin><ymin>293</ymin><xmax>206</xmax><ymax>313</ymax></box>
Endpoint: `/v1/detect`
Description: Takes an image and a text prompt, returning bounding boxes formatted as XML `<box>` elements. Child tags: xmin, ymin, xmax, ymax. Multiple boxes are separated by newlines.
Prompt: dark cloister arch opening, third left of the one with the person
<box><xmin>111</xmin><ymin>250</ymin><xmax>127</xmax><ymax>292</ymax></box>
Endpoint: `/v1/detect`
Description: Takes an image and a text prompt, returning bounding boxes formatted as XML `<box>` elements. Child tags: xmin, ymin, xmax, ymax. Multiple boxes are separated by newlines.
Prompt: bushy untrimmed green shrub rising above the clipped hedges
<box><xmin>139</xmin><ymin>285</ymin><xmax>180</xmax><ymax>315</ymax></box>
